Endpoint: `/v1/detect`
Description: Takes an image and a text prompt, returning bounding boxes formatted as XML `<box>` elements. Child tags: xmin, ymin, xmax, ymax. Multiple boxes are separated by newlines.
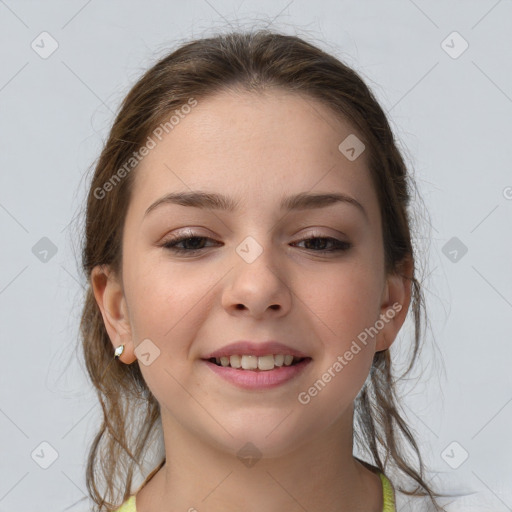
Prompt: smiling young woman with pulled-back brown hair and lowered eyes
<box><xmin>81</xmin><ymin>31</ymin><xmax>456</xmax><ymax>512</ymax></box>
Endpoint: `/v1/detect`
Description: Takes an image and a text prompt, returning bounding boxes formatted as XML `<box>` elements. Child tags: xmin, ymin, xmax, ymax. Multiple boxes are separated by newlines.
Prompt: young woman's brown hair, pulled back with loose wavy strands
<box><xmin>80</xmin><ymin>30</ymin><xmax>443</xmax><ymax>511</ymax></box>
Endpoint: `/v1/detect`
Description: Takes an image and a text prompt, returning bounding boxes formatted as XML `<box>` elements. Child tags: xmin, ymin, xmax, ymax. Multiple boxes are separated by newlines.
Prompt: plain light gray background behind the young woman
<box><xmin>0</xmin><ymin>0</ymin><xmax>512</xmax><ymax>512</ymax></box>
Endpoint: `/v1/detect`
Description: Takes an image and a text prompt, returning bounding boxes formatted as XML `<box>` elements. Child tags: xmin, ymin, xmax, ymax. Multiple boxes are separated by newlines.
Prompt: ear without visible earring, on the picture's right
<box><xmin>375</xmin><ymin>256</ymin><xmax>414</xmax><ymax>352</ymax></box>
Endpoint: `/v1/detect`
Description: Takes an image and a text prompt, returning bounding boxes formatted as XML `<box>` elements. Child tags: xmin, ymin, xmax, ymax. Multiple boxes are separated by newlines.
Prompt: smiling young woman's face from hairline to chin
<box><xmin>97</xmin><ymin>91</ymin><xmax>407</xmax><ymax>457</ymax></box>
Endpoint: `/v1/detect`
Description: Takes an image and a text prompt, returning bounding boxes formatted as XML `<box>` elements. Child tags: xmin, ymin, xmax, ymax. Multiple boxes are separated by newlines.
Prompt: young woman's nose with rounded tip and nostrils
<box><xmin>222</xmin><ymin>238</ymin><xmax>292</xmax><ymax>319</ymax></box>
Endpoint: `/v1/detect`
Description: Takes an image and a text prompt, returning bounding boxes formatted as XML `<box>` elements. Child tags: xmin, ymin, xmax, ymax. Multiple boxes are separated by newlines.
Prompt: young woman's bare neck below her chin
<box><xmin>136</xmin><ymin>409</ymin><xmax>383</xmax><ymax>512</ymax></box>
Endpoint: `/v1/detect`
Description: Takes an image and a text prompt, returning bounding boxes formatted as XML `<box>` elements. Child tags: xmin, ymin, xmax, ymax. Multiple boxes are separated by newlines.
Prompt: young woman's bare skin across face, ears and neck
<box><xmin>91</xmin><ymin>90</ymin><xmax>412</xmax><ymax>512</ymax></box>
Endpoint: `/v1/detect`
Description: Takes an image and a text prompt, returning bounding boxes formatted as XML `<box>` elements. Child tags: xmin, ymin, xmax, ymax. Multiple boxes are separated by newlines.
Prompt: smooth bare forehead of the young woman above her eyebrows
<box><xmin>126</xmin><ymin>90</ymin><xmax>376</xmax><ymax>220</ymax></box>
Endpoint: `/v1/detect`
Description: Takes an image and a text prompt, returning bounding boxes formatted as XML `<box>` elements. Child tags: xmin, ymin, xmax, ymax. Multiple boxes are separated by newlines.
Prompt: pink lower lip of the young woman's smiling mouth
<box><xmin>204</xmin><ymin>358</ymin><xmax>311</xmax><ymax>389</ymax></box>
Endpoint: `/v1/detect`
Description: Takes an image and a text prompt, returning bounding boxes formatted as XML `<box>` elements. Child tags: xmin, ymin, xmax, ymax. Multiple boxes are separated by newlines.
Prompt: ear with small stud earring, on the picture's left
<box><xmin>91</xmin><ymin>265</ymin><xmax>137</xmax><ymax>364</ymax></box>
